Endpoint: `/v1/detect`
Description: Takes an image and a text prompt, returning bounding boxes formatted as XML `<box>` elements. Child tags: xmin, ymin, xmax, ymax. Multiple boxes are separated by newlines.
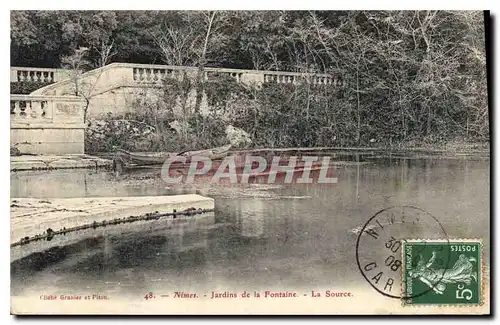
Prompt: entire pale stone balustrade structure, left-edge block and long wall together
<box><xmin>10</xmin><ymin>63</ymin><xmax>342</xmax><ymax>154</ymax></box>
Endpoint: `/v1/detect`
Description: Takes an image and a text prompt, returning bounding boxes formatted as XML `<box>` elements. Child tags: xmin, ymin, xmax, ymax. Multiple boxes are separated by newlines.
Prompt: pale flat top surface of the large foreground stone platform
<box><xmin>10</xmin><ymin>194</ymin><xmax>214</xmax><ymax>254</ymax></box>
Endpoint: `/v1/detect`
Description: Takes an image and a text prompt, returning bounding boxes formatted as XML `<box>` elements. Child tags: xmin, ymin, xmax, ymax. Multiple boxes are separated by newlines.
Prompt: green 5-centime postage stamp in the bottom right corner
<box><xmin>403</xmin><ymin>239</ymin><xmax>483</xmax><ymax>306</ymax></box>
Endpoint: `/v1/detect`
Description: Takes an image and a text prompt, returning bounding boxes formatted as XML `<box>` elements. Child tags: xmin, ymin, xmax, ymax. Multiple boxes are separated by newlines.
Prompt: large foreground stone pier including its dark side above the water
<box><xmin>10</xmin><ymin>194</ymin><xmax>214</xmax><ymax>262</ymax></box>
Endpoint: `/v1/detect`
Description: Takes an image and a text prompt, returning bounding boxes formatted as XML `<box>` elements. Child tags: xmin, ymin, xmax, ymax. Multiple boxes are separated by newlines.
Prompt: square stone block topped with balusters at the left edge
<box><xmin>10</xmin><ymin>95</ymin><xmax>85</xmax><ymax>154</ymax></box>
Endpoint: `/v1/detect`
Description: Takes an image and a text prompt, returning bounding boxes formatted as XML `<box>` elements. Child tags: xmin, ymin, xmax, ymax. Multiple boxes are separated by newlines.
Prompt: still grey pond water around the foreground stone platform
<box><xmin>11</xmin><ymin>157</ymin><xmax>490</xmax><ymax>297</ymax></box>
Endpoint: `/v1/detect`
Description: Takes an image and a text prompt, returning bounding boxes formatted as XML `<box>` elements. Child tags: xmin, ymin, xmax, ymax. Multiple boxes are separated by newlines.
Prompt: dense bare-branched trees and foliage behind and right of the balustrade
<box><xmin>11</xmin><ymin>11</ymin><xmax>489</xmax><ymax>146</ymax></box>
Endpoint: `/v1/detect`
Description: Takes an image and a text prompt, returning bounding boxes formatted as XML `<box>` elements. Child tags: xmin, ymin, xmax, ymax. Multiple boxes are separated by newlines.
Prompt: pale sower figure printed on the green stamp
<box><xmin>409</xmin><ymin>251</ymin><xmax>477</xmax><ymax>294</ymax></box>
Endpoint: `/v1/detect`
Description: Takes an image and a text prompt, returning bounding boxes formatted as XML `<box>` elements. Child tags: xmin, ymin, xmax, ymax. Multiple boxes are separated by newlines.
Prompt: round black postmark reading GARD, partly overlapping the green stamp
<box><xmin>356</xmin><ymin>206</ymin><xmax>450</xmax><ymax>299</ymax></box>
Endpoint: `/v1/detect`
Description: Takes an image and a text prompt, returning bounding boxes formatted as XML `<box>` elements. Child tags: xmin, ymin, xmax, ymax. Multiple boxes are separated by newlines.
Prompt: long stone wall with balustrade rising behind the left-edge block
<box><xmin>27</xmin><ymin>63</ymin><xmax>342</xmax><ymax>118</ymax></box>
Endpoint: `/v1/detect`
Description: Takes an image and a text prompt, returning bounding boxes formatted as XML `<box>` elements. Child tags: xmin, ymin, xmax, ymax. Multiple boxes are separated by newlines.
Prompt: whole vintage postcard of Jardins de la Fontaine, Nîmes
<box><xmin>10</xmin><ymin>10</ymin><xmax>491</xmax><ymax>315</ymax></box>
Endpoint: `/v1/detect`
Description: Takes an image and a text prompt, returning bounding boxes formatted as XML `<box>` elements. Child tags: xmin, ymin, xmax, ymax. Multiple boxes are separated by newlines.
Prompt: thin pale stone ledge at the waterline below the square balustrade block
<box><xmin>10</xmin><ymin>155</ymin><xmax>113</xmax><ymax>171</ymax></box>
